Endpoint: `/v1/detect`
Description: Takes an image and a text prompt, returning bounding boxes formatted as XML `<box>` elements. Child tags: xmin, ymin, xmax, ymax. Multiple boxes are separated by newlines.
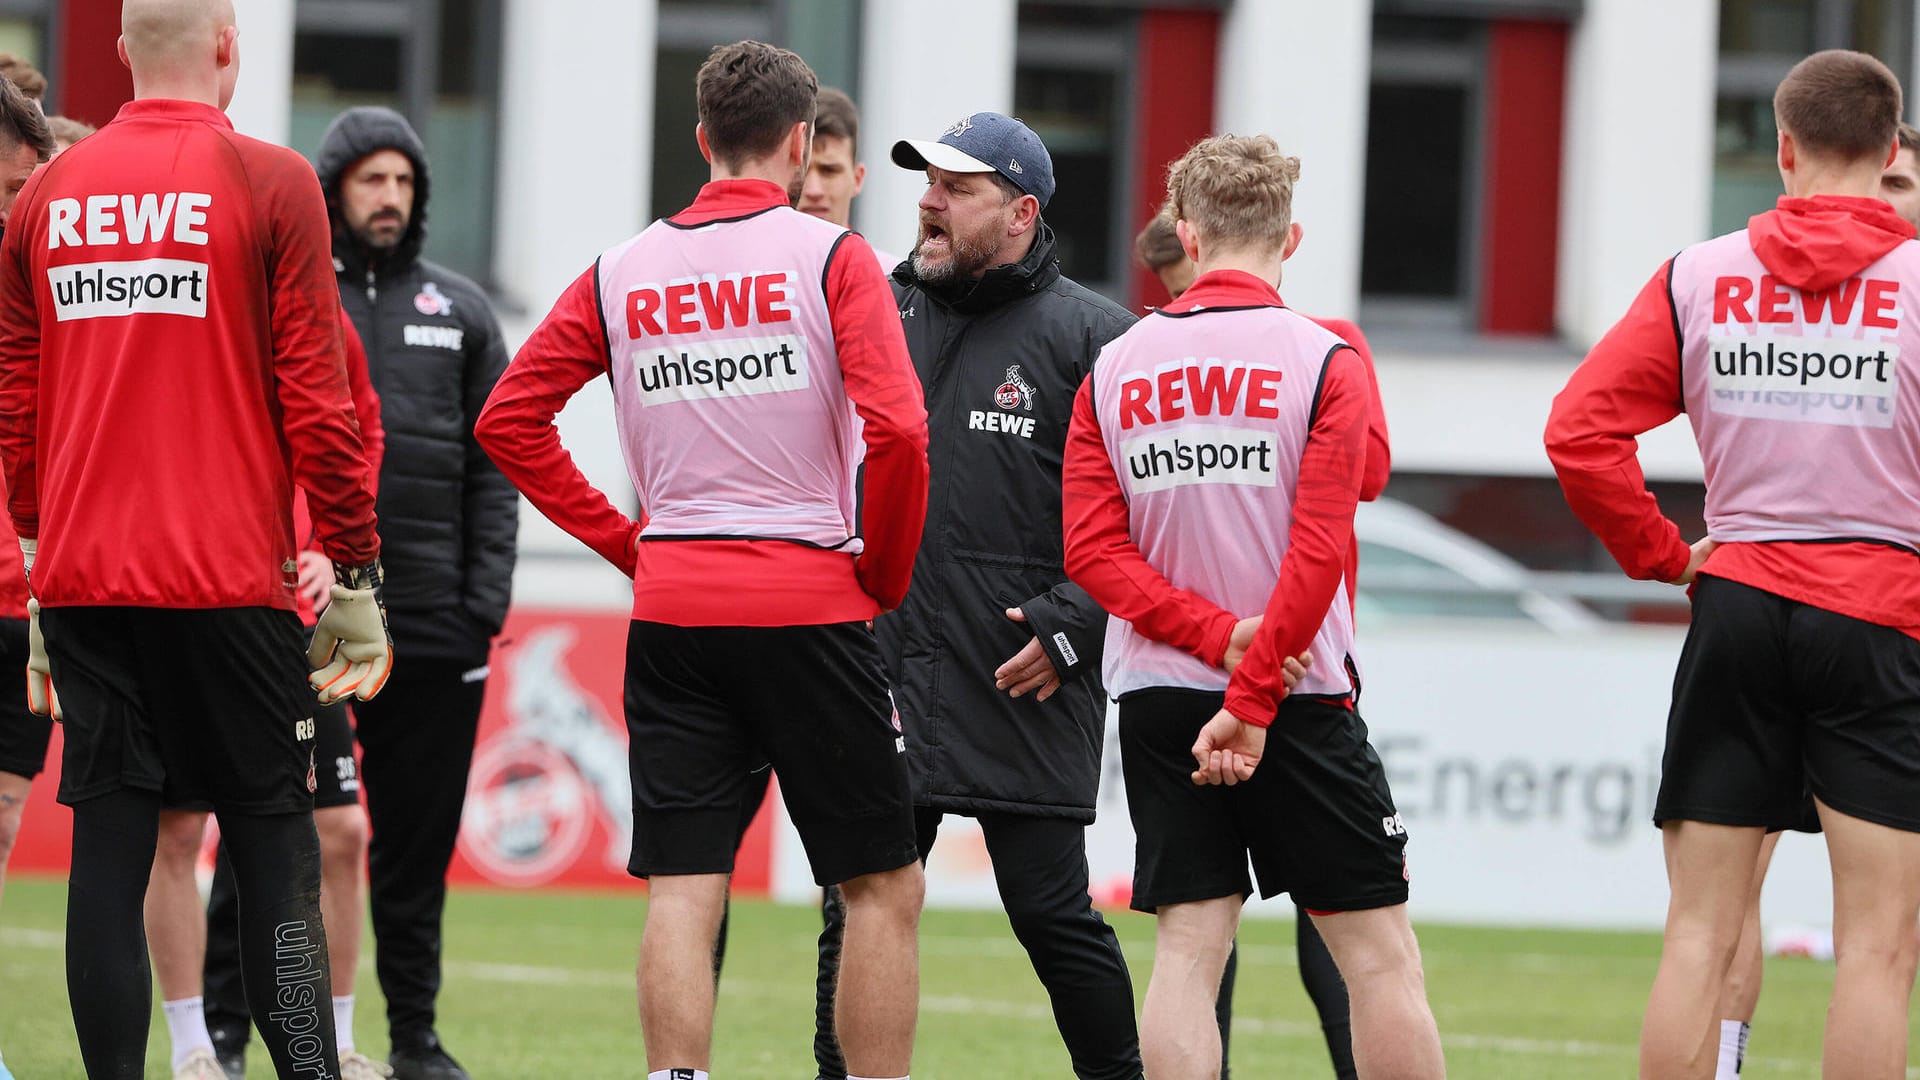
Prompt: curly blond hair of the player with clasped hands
<box><xmin>1167</xmin><ymin>135</ymin><xmax>1300</xmax><ymax>250</ymax></box>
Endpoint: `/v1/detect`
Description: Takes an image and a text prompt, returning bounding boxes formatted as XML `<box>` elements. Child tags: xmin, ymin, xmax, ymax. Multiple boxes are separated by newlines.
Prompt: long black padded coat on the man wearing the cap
<box><xmin>876</xmin><ymin>223</ymin><xmax>1133</xmax><ymax>821</ymax></box>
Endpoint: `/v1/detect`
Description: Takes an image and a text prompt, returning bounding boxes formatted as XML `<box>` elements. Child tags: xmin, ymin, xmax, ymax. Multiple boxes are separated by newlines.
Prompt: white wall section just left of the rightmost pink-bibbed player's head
<box><xmin>1557</xmin><ymin>0</ymin><xmax>1720</xmax><ymax>348</ymax></box>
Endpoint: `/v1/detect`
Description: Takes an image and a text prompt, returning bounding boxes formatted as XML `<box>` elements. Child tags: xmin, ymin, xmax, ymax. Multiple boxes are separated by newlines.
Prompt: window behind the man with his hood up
<box><xmin>290</xmin><ymin>0</ymin><xmax>501</xmax><ymax>284</ymax></box>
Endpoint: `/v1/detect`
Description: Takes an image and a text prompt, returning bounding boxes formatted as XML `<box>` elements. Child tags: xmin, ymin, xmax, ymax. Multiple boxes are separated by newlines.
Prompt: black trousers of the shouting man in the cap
<box><xmin>814</xmin><ymin>807</ymin><xmax>1140</xmax><ymax>1080</ymax></box>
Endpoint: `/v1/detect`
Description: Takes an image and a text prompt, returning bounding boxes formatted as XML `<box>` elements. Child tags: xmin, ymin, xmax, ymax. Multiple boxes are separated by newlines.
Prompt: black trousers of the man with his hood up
<box><xmin>353</xmin><ymin>657</ymin><xmax>486</xmax><ymax>1049</ymax></box>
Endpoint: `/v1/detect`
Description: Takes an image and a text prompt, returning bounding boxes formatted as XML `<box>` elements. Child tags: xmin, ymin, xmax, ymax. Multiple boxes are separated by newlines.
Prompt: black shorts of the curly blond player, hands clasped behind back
<box><xmin>1119</xmin><ymin>690</ymin><xmax>1407</xmax><ymax>911</ymax></box>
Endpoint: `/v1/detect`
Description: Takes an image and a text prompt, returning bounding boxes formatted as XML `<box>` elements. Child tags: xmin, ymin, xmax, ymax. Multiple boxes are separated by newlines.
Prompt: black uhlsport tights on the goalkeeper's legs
<box><xmin>67</xmin><ymin>790</ymin><xmax>340</xmax><ymax>1080</ymax></box>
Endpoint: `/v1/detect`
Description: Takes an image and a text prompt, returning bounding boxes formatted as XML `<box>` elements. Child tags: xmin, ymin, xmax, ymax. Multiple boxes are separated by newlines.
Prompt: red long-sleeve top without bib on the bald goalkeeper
<box><xmin>0</xmin><ymin>100</ymin><xmax>380</xmax><ymax>609</ymax></box>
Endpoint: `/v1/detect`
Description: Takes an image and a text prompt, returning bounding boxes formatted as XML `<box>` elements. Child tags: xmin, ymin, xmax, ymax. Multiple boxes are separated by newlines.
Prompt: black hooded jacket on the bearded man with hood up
<box><xmin>317</xmin><ymin>108</ymin><xmax>520</xmax><ymax>665</ymax></box>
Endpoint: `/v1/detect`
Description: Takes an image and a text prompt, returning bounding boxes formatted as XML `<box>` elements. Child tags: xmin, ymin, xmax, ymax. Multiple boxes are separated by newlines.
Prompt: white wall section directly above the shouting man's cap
<box><xmin>852</xmin><ymin>0</ymin><xmax>1018</xmax><ymax>256</ymax></box>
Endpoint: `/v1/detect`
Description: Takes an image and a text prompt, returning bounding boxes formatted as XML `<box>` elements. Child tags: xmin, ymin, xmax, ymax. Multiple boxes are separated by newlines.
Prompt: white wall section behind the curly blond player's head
<box><xmin>1213</xmin><ymin>0</ymin><xmax>1373</xmax><ymax>317</ymax></box>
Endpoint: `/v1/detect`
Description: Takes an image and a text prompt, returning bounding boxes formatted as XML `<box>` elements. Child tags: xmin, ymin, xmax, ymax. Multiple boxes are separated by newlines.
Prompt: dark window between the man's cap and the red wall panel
<box><xmin>1014</xmin><ymin>4</ymin><xmax>1139</xmax><ymax>300</ymax></box>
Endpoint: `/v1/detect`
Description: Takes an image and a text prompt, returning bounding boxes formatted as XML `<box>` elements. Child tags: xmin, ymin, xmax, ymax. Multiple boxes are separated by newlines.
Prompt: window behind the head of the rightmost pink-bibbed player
<box><xmin>1711</xmin><ymin>0</ymin><xmax>1914</xmax><ymax>234</ymax></box>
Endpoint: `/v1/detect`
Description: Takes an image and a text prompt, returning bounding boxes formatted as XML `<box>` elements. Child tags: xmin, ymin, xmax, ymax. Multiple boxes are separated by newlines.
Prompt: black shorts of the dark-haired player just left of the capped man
<box><xmin>626</xmin><ymin>621</ymin><xmax>920</xmax><ymax>886</ymax></box>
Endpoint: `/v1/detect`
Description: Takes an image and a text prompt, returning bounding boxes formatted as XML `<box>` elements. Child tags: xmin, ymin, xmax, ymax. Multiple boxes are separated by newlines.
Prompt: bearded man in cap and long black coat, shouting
<box><xmin>806</xmin><ymin>113</ymin><xmax>1140</xmax><ymax>1080</ymax></box>
